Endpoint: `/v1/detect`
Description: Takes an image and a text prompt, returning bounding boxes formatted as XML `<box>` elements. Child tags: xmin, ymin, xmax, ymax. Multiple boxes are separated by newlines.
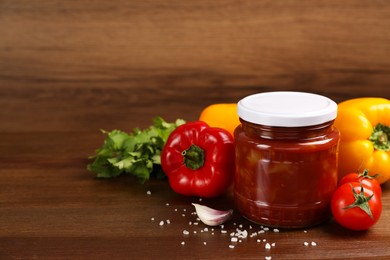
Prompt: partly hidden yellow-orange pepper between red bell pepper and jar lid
<box><xmin>199</xmin><ymin>103</ymin><xmax>240</xmax><ymax>136</ymax></box>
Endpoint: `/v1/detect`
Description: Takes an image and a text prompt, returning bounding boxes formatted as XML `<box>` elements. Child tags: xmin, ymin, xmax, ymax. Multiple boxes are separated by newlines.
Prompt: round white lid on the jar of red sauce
<box><xmin>237</xmin><ymin>91</ymin><xmax>337</xmax><ymax>127</ymax></box>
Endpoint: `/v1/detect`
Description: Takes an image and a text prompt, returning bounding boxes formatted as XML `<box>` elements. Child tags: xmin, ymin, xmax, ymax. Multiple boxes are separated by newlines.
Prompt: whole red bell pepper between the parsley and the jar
<box><xmin>161</xmin><ymin>121</ymin><xmax>235</xmax><ymax>198</ymax></box>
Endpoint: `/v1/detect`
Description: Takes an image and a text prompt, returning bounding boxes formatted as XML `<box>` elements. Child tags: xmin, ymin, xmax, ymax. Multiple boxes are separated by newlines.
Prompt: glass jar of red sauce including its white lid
<box><xmin>234</xmin><ymin>92</ymin><xmax>339</xmax><ymax>228</ymax></box>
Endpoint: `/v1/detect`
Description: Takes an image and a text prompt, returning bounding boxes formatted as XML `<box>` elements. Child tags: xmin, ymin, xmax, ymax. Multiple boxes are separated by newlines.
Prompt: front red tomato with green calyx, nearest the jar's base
<box><xmin>331</xmin><ymin>182</ymin><xmax>382</xmax><ymax>230</ymax></box>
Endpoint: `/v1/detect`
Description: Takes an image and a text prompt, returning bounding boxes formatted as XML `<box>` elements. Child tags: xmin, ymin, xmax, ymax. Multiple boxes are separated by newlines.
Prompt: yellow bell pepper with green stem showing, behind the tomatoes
<box><xmin>335</xmin><ymin>97</ymin><xmax>390</xmax><ymax>183</ymax></box>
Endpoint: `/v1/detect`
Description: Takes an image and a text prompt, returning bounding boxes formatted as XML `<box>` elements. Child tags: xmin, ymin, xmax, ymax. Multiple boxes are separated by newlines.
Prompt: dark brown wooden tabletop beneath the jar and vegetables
<box><xmin>0</xmin><ymin>132</ymin><xmax>390</xmax><ymax>259</ymax></box>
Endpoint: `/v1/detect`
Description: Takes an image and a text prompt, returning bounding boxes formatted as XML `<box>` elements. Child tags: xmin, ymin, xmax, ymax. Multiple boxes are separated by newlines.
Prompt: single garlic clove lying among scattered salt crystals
<box><xmin>192</xmin><ymin>203</ymin><xmax>233</xmax><ymax>226</ymax></box>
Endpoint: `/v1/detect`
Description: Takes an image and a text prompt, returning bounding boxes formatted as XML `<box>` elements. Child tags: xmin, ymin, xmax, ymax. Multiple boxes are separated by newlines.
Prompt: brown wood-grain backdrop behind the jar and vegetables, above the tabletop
<box><xmin>0</xmin><ymin>0</ymin><xmax>390</xmax><ymax>132</ymax></box>
